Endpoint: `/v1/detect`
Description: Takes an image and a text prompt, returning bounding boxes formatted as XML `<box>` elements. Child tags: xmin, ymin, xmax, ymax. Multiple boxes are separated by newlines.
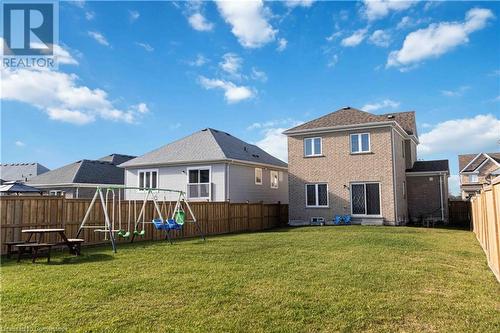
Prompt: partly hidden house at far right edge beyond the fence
<box><xmin>458</xmin><ymin>153</ymin><xmax>500</xmax><ymax>200</ymax></box>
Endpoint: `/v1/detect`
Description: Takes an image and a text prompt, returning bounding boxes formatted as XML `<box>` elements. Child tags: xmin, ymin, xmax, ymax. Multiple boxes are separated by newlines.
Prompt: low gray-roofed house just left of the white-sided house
<box><xmin>27</xmin><ymin>154</ymin><xmax>135</xmax><ymax>198</ymax></box>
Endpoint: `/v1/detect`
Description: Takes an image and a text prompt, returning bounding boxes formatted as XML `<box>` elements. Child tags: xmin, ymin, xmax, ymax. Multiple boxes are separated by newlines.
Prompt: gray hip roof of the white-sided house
<box><xmin>120</xmin><ymin>128</ymin><xmax>287</xmax><ymax>168</ymax></box>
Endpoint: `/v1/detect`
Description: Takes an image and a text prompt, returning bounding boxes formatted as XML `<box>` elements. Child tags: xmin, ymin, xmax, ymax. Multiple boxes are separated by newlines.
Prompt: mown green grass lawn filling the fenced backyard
<box><xmin>1</xmin><ymin>226</ymin><xmax>500</xmax><ymax>332</ymax></box>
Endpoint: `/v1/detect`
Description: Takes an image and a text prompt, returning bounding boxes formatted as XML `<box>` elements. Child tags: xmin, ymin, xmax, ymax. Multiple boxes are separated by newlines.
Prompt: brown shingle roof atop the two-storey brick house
<box><xmin>285</xmin><ymin>107</ymin><xmax>417</xmax><ymax>135</ymax></box>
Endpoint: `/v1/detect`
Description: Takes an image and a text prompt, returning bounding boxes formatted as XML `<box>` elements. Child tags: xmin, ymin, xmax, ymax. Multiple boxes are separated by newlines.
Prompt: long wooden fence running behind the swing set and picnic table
<box><xmin>0</xmin><ymin>196</ymin><xmax>288</xmax><ymax>253</ymax></box>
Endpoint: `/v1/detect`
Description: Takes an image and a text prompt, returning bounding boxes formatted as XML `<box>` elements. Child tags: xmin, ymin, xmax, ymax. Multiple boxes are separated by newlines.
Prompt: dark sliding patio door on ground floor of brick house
<box><xmin>351</xmin><ymin>183</ymin><xmax>380</xmax><ymax>215</ymax></box>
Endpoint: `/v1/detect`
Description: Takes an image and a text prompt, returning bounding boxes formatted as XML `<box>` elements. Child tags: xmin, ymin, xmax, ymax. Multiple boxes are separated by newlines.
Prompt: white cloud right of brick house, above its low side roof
<box><xmin>418</xmin><ymin>114</ymin><xmax>500</xmax><ymax>156</ymax></box>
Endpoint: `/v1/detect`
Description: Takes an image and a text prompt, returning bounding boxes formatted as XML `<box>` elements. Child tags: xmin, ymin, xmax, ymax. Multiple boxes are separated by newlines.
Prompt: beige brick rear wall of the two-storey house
<box><xmin>288</xmin><ymin>127</ymin><xmax>395</xmax><ymax>222</ymax></box>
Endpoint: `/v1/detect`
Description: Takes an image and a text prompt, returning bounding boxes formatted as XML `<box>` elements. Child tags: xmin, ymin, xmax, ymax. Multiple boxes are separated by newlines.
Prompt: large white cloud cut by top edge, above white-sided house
<box><xmin>217</xmin><ymin>0</ymin><xmax>277</xmax><ymax>48</ymax></box>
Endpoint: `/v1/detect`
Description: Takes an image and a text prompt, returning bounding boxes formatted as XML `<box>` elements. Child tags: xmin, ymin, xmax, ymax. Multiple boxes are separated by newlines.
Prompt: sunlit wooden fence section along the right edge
<box><xmin>471</xmin><ymin>177</ymin><xmax>500</xmax><ymax>282</ymax></box>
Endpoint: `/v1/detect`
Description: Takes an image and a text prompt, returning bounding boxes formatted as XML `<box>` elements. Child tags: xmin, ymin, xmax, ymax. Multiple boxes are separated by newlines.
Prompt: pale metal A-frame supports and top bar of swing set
<box><xmin>76</xmin><ymin>185</ymin><xmax>205</xmax><ymax>253</ymax></box>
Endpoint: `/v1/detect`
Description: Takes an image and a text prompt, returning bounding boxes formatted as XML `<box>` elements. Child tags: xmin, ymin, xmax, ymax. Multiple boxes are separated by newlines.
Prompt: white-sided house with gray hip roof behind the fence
<box><xmin>120</xmin><ymin>128</ymin><xmax>288</xmax><ymax>203</ymax></box>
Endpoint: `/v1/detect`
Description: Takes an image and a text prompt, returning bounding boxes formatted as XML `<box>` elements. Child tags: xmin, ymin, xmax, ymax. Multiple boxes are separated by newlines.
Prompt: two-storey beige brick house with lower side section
<box><xmin>284</xmin><ymin>107</ymin><xmax>449</xmax><ymax>225</ymax></box>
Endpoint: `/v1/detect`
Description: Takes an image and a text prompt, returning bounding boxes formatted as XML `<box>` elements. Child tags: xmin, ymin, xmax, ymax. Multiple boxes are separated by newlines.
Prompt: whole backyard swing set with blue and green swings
<box><xmin>76</xmin><ymin>185</ymin><xmax>205</xmax><ymax>253</ymax></box>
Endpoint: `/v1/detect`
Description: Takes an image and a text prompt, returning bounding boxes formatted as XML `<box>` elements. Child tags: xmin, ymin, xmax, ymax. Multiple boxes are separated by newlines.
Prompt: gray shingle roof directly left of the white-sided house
<box><xmin>28</xmin><ymin>160</ymin><xmax>133</xmax><ymax>185</ymax></box>
